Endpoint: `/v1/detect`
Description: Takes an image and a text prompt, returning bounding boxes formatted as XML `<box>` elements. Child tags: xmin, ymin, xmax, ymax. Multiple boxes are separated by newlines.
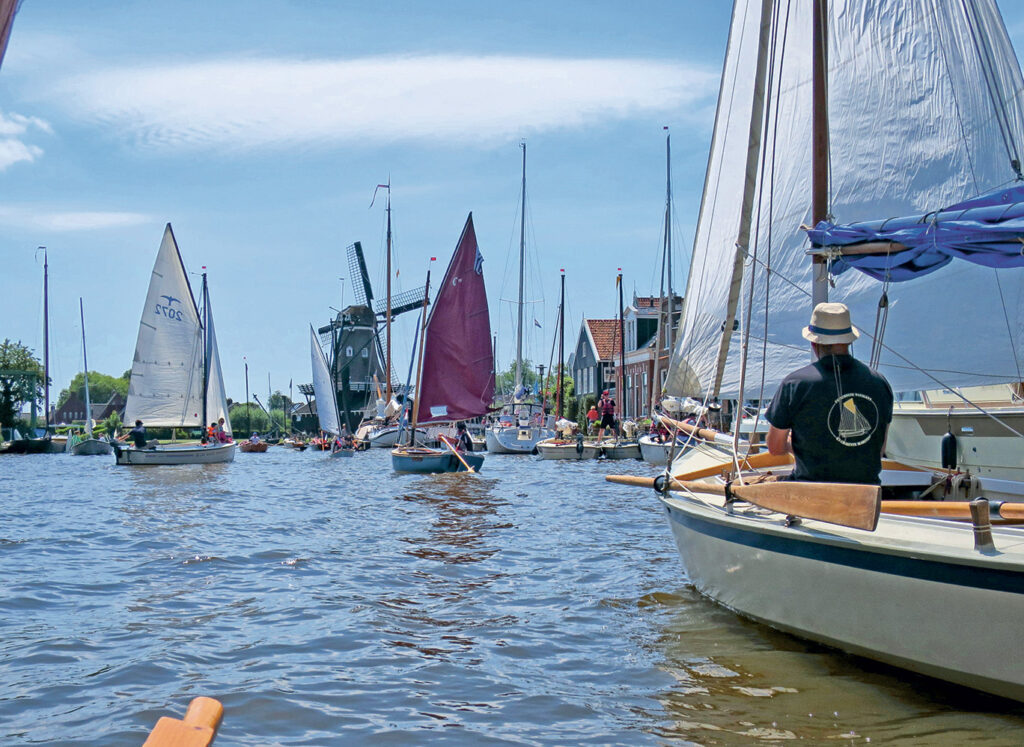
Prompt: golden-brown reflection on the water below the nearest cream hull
<box><xmin>640</xmin><ymin>588</ymin><xmax>1024</xmax><ymax>745</ymax></box>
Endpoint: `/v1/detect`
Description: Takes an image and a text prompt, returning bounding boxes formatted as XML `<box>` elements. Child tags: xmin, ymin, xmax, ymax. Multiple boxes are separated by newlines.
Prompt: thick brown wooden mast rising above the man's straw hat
<box><xmin>811</xmin><ymin>0</ymin><xmax>828</xmax><ymax>305</ymax></box>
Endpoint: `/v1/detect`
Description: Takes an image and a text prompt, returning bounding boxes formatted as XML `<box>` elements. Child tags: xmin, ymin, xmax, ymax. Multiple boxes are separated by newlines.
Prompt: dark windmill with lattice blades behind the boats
<box><xmin>311</xmin><ymin>242</ymin><xmax>426</xmax><ymax>432</ymax></box>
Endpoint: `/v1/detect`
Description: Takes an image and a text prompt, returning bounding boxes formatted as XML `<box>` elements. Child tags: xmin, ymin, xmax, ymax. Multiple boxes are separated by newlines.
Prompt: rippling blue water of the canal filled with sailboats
<box><xmin>0</xmin><ymin>447</ymin><xmax>1024</xmax><ymax>747</ymax></box>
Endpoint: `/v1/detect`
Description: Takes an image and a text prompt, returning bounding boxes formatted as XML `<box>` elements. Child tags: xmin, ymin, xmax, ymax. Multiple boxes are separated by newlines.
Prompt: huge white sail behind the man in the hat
<box><xmin>667</xmin><ymin>0</ymin><xmax>1024</xmax><ymax>398</ymax></box>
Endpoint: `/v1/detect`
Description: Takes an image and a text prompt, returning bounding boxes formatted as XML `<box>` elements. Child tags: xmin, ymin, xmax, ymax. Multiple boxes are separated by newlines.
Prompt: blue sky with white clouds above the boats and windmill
<box><xmin>6</xmin><ymin>0</ymin><xmax>1024</xmax><ymax>401</ymax></box>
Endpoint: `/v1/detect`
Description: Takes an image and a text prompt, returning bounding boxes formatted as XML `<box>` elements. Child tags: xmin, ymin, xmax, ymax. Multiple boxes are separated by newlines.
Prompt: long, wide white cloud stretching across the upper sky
<box><xmin>55</xmin><ymin>55</ymin><xmax>718</xmax><ymax>149</ymax></box>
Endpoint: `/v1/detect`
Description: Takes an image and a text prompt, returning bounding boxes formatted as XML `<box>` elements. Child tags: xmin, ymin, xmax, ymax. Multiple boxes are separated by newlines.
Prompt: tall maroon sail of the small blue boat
<box><xmin>418</xmin><ymin>213</ymin><xmax>495</xmax><ymax>423</ymax></box>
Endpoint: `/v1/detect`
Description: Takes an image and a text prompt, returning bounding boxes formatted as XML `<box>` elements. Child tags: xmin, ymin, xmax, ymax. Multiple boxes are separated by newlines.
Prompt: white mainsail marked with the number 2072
<box><xmin>125</xmin><ymin>223</ymin><xmax>204</xmax><ymax>427</ymax></box>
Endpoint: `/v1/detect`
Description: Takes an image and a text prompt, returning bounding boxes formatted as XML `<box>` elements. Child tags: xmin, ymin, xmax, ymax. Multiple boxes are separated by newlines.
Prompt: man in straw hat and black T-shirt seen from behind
<box><xmin>766</xmin><ymin>303</ymin><xmax>893</xmax><ymax>485</ymax></box>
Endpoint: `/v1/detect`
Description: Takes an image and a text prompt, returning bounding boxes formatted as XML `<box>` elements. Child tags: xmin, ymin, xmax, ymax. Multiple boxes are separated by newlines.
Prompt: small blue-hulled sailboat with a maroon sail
<box><xmin>391</xmin><ymin>213</ymin><xmax>495</xmax><ymax>472</ymax></box>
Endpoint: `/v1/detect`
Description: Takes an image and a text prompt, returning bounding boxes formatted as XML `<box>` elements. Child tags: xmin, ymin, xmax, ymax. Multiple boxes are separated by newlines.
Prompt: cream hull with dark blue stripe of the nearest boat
<box><xmin>662</xmin><ymin>483</ymin><xmax>1024</xmax><ymax>700</ymax></box>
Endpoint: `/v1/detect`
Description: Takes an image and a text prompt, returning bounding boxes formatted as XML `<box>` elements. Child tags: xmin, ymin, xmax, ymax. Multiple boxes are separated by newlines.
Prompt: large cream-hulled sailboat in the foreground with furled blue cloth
<box><xmin>612</xmin><ymin>0</ymin><xmax>1024</xmax><ymax>700</ymax></box>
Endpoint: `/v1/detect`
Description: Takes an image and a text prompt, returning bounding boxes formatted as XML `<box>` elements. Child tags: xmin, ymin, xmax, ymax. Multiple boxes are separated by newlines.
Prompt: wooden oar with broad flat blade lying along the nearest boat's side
<box><xmin>605</xmin><ymin>474</ymin><xmax>882</xmax><ymax>532</ymax></box>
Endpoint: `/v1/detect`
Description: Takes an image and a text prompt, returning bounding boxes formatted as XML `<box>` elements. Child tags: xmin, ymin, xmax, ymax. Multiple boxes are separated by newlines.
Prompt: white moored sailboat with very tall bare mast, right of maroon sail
<box><xmin>485</xmin><ymin>142</ymin><xmax>555</xmax><ymax>454</ymax></box>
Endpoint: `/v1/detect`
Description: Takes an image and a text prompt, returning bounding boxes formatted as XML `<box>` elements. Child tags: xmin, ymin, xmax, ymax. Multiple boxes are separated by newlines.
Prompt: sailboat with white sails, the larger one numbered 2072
<box><xmin>114</xmin><ymin>223</ymin><xmax>234</xmax><ymax>464</ymax></box>
